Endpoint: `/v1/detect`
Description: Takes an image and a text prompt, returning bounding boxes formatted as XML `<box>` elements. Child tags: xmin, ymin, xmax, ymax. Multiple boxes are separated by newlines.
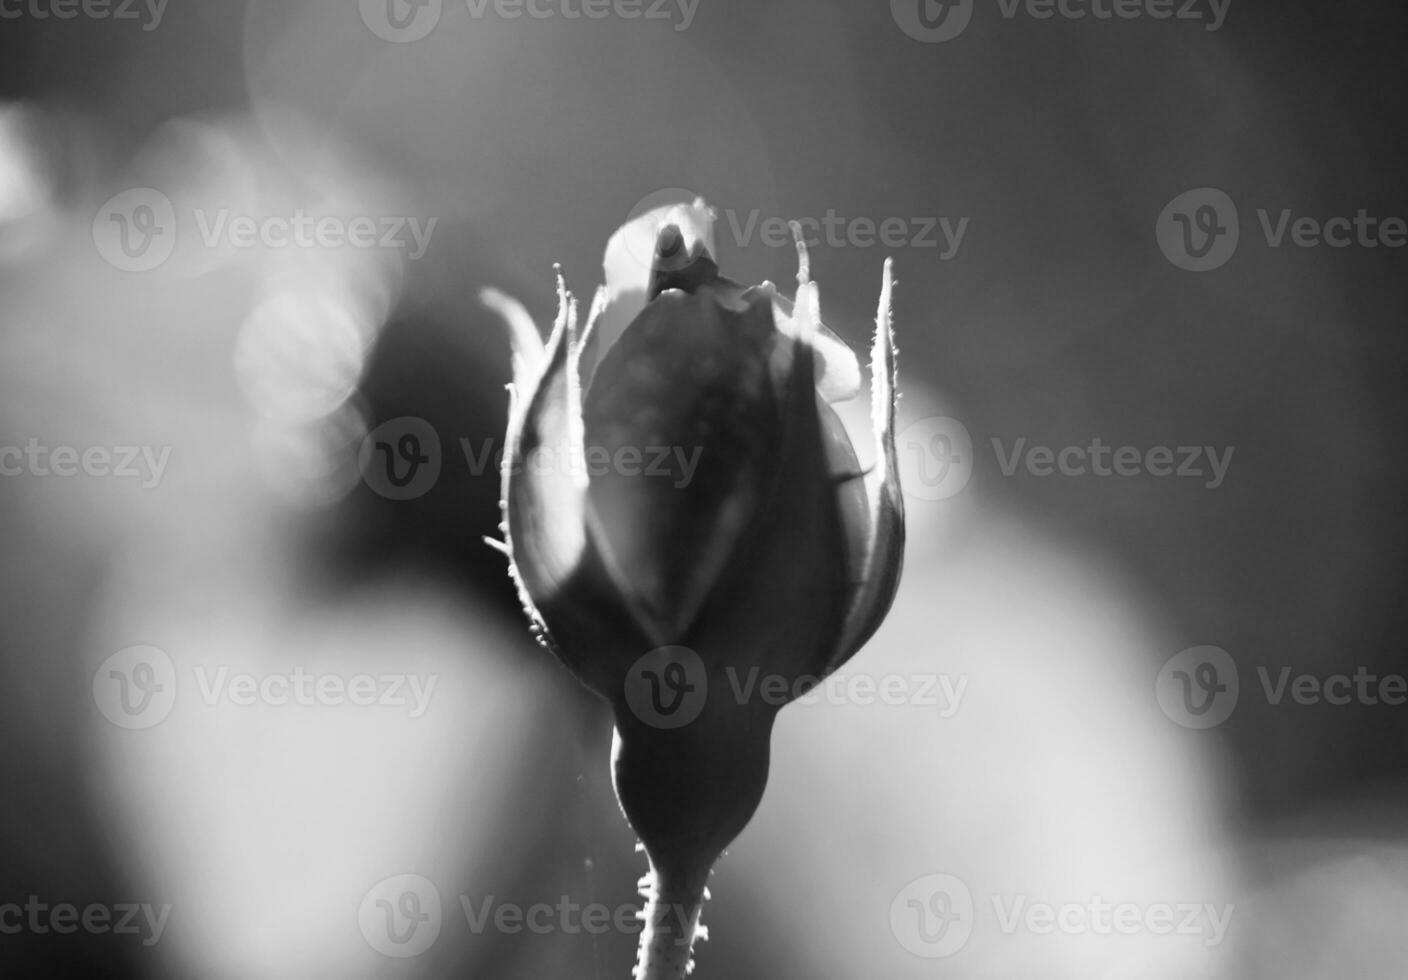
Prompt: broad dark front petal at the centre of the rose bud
<box><xmin>586</xmin><ymin>290</ymin><xmax>780</xmax><ymax>645</ymax></box>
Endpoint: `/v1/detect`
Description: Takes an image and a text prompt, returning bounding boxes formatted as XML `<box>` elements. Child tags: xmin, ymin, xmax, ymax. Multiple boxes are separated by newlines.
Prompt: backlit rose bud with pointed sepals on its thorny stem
<box><xmin>484</xmin><ymin>203</ymin><xmax>904</xmax><ymax>977</ymax></box>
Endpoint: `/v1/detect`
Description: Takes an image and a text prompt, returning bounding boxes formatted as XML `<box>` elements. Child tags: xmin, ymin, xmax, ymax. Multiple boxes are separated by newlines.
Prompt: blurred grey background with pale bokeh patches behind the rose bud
<box><xmin>0</xmin><ymin>0</ymin><xmax>1408</xmax><ymax>980</ymax></box>
